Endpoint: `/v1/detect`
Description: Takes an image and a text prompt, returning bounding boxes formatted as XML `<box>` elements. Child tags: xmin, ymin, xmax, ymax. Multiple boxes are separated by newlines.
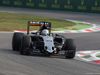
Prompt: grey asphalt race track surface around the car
<box><xmin>0</xmin><ymin>7</ymin><xmax>100</xmax><ymax>75</ymax></box>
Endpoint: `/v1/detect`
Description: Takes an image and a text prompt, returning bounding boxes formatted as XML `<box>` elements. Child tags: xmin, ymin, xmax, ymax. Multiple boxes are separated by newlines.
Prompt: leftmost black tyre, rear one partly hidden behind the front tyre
<box><xmin>12</xmin><ymin>32</ymin><xmax>24</xmax><ymax>51</ymax></box>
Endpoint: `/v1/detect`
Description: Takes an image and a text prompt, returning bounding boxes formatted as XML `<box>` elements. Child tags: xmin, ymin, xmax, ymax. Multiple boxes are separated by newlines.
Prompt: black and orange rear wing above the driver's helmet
<box><xmin>27</xmin><ymin>21</ymin><xmax>51</xmax><ymax>34</ymax></box>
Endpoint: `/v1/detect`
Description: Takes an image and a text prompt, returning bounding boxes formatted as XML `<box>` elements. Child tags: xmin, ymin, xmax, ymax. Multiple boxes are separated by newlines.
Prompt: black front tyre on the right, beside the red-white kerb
<box><xmin>64</xmin><ymin>39</ymin><xmax>76</xmax><ymax>59</ymax></box>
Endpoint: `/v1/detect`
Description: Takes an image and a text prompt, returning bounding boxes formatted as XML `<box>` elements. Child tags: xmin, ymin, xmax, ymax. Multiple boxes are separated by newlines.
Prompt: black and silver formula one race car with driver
<box><xmin>12</xmin><ymin>21</ymin><xmax>76</xmax><ymax>59</ymax></box>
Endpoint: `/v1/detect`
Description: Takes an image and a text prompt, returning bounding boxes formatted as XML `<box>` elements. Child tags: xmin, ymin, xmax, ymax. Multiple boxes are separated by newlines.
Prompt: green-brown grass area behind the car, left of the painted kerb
<box><xmin>0</xmin><ymin>12</ymin><xmax>75</xmax><ymax>31</ymax></box>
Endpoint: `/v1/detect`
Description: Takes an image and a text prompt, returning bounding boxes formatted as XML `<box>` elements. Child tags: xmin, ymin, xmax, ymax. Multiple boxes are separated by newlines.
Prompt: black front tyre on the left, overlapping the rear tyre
<box><xmin>20</xmin><ymin>35</ymin><xmax>31</xmax><ymax>55</ymax></box>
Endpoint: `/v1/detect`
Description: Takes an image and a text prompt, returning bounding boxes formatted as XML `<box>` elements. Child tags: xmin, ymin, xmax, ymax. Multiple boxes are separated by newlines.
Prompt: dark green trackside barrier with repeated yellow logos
<box><xmin>0</xmin><ymin>0</ymin><xmax>100</xmax><ymax>13</ymax></box>
